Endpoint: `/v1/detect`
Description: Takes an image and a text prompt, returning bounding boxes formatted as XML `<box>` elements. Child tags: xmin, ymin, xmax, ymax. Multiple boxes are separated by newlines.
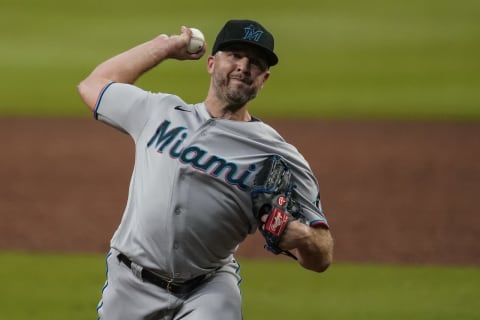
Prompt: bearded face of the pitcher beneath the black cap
<box><xmin>208</xmin><ymin>45</ymin><xmax>270</xmax><ymax>108</ymax></box>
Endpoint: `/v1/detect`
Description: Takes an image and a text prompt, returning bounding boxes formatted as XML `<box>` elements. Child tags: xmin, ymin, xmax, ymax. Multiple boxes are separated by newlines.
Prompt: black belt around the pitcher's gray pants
<box><xmin>117</xmin><ymin>253</ymin><xmax>209</xmax><ymax>294</ymax></box>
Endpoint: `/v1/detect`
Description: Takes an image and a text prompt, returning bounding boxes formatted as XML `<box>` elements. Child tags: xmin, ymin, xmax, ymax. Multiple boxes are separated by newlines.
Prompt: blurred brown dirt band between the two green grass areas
<box><xmin>0</xmin><ymin>118</ymin><xmax>480</xmax><ymax>265</ymax></box>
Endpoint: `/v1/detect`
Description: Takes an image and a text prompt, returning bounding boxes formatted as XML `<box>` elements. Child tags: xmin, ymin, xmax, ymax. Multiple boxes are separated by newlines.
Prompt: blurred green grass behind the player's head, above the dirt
<box><xmin>0</xmin><ymin>0</ymin><xmax>480</xmax><ymax>120</ymax></box>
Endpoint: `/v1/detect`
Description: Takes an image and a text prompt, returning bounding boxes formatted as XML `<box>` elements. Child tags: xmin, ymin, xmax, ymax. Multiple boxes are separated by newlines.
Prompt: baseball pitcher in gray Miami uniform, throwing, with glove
<box><xmin>78</xmin><ymin>20</ymin><xmax>333</xmax><ymax>320</ymax></box>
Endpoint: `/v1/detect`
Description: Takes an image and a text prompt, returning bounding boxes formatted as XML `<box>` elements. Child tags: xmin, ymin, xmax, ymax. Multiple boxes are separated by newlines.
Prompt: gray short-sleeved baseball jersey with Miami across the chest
<box><xmin>95</xmin><ymin>83</ymin><xmax>327</xmax><ymax>280</ymax></box>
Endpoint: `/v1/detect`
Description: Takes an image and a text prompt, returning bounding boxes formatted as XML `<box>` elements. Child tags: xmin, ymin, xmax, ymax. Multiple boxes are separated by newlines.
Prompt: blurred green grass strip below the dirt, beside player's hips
<box><xmin>0</xmin><ymin>252</ymin><xmax>480</xmax><ymax>320</ymax></box>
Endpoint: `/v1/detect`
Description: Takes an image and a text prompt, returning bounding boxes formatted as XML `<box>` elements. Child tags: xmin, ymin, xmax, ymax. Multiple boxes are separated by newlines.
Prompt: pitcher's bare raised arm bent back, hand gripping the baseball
<box><xmin>77</xmin><ymin>27</ymin><xmax>206</xmax><ymax>111</ymax></box>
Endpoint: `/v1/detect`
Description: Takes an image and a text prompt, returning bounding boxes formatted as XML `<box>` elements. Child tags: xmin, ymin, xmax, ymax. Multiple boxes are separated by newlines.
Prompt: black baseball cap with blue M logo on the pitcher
<box><xmin>212</xmin><ymin>20</ymin><xmax>278</xmax><ymax>66</ymax></box>
